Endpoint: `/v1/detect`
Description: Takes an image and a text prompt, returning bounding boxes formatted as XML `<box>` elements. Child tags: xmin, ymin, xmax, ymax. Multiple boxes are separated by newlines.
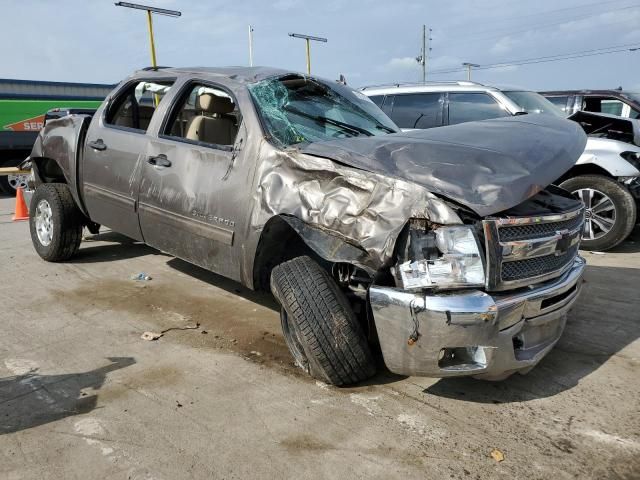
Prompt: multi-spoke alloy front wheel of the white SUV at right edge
<box><xmin>560</xmin><ymin>175</ymin><xmax>636</xmax><ymax>251</ymax></box>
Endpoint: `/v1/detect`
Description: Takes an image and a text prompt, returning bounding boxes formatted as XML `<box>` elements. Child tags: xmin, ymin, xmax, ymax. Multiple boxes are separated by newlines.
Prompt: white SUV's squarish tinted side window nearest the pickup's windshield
<box><xmin>391</xmin><ymin>93</ymin><xmax>442</xmax><ymax>128</ymax></box>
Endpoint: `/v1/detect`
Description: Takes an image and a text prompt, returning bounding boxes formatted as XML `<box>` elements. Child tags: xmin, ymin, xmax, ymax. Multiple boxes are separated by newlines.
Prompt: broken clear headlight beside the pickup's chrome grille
<box><xmin>398</xmin><ymin>226</ymin><xmax>485</xmax><ymax>290</ymax></box>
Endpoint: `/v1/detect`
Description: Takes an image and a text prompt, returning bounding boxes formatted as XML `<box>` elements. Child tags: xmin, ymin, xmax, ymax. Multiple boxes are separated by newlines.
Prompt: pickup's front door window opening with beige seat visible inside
<box><xmin>164</xmin><ymin>85</ymin><xmax>240</xmax><ymax>146</ymax></box>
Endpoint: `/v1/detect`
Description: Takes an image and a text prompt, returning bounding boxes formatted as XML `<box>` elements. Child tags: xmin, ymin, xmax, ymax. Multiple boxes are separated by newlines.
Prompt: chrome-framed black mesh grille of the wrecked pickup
<box><xmin>482</xmin><ymin>207</ymin><xmax>584</xmax><ymax>291</ymax></box>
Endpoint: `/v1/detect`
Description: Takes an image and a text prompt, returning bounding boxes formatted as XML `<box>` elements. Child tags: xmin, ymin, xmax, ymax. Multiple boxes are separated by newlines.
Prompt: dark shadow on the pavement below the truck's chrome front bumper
<box><xmin>424</xmin><ymin>266</ymin><xmax>640</xmax><ymax>403</ymax></box>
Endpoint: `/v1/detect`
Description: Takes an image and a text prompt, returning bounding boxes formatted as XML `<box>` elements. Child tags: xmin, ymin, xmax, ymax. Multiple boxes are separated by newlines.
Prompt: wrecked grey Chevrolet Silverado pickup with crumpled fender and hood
<box><xmin>30</xmin><ymin>68</ymin><xmax>586</xmax><ymax>385</ymax></box>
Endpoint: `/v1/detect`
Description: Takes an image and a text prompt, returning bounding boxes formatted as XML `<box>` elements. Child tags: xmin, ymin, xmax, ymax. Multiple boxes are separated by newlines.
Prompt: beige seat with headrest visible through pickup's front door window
<box><xmin>186</xmin><ymin>93</ymin><xmax>237</xmax><ymax>145</ymax></box>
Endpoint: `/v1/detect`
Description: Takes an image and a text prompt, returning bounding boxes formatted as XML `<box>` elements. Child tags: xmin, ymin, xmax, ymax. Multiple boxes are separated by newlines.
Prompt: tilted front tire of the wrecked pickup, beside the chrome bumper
<box><xmin>271</xmin><ymin>257</ymin><xmax>376</xmax><ymax>385</ymax></box>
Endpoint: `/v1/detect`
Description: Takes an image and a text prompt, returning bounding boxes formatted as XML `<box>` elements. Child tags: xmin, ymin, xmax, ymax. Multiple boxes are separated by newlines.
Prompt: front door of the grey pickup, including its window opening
<box><xmin>139</xmin><ymin>83</ymin><xmax>246</xmax><ymax>279</ymax></box>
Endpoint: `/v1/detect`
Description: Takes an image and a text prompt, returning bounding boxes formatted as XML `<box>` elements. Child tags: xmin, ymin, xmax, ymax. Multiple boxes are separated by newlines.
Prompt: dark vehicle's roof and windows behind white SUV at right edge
<box><xmin>540</xmin><ymin>88</ymin><xmax>640</xmax><ymax>119</ymax></box>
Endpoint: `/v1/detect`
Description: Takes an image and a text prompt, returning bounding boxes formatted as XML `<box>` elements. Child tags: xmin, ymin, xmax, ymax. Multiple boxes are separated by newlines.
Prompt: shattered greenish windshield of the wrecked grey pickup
<box><xmin>249</xmin><ymin>75</ymin><xmax>399</xmax><ymax>146</ymax></box>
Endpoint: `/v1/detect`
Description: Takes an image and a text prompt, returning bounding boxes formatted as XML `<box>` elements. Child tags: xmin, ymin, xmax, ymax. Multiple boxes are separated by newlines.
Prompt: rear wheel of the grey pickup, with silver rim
<box><xmin>29</xmin><ymin>183</ymin><xmax>84</xmax><ymax>262</ymax></box>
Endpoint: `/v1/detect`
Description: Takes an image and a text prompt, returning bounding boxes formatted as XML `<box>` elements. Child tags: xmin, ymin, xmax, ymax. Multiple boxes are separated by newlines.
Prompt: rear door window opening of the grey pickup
<box><xmin>105</xmin><ymin>81</ymin><xmax>173</xmax><ymax>132</ymax></box>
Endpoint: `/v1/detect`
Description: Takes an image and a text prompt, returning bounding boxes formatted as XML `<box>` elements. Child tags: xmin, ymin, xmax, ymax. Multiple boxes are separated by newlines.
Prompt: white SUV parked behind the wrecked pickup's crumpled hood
<box><xmin>362</xmin><ymin>82</ymin><xmax>640</xmax><ymax>250</ymax></box>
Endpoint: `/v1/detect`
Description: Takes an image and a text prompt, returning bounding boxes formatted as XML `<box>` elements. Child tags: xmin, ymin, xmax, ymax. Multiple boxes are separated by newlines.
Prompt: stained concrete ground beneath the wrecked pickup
<box><xmin>0</xmin><ymin>198</ymin><xmax>640</xmax><ymax>480</ymax></box>
